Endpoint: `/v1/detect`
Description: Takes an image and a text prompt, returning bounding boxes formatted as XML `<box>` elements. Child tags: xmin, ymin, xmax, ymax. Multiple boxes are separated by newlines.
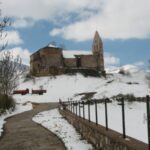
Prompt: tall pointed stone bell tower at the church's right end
<box><xmin>92</xmin><ymin>31</ymin><xmax>104</xmax><ymax>72</ymax></box>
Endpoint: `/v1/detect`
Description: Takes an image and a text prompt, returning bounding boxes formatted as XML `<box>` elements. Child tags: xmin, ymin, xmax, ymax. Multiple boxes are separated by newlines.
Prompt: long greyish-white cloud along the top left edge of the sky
<box><xmin>2</xmin><ymin>0</ymin><xmax>101</xmax><ymax>21</ymax></box>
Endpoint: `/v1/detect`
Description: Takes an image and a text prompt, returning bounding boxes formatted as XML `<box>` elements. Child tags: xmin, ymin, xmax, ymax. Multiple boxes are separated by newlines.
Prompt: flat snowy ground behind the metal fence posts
<box><xmin>71</xmin><ymin>102</ymin><xmax>148</xmax><ymax>143</ymax></box>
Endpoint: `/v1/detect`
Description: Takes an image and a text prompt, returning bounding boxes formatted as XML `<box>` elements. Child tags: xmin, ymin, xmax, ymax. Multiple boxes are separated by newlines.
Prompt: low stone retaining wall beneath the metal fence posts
<box><xmin>60</xmin><ymin>110</ymin><xmax>148</xmax><ymax>150</ymax></box>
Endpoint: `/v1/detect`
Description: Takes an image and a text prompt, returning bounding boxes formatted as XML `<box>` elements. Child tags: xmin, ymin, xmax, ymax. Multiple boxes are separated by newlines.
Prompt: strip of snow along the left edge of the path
<box><xmin>0</xmin><ymin>102</ymin><xmax>32</xmax><ymax>136</ymax></box>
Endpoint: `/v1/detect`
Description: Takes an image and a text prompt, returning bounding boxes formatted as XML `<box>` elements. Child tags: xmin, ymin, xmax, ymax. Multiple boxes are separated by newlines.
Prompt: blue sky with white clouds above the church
<box><xmin>0</xmin><ymin>0</ymin><xmax>150</xmax><ymax>67</ymax></box>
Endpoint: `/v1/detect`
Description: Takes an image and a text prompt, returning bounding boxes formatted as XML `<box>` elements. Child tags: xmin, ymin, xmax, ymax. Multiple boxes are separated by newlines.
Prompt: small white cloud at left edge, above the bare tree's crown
<box><xmin>0</xmin><ymin>31</ymin><xmax>23</xmax><ymax>46</ymax></box>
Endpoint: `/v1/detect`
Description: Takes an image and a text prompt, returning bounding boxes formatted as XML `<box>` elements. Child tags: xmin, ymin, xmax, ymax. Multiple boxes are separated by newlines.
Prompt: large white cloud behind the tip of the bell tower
<box><xmin>50</xmin><ymin>0</ymin><xmax>150</xmax><ymax>41</ymax></box>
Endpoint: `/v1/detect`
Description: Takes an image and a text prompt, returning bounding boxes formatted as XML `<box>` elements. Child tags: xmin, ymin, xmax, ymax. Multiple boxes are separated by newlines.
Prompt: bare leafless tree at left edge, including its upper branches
<box><xmin>0</xmin><ymin>11</ymin><xmax>25</xmax><ymax>96</ymax></box>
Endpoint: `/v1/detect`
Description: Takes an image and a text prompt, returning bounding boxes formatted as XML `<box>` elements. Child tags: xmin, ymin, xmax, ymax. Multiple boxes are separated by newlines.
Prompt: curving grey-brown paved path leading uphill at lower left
<box><xmin>0</xmin><ymin>103</ymin><xmax>66</xmax><ymax>150</ymax></box>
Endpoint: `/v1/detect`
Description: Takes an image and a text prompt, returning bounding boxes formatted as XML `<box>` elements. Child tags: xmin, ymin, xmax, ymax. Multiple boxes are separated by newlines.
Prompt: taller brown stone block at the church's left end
<box><xmin>30</xmin><ymin>47</ymin><xmax>64</xmax><ymax>76</ymax></box>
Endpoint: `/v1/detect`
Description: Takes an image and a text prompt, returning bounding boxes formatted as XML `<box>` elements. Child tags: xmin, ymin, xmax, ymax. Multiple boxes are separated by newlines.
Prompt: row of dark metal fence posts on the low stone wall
<box><xmin>60</xmin><ymin>96</ymin><xmax>150</xmax><ymax>150</ymax></box>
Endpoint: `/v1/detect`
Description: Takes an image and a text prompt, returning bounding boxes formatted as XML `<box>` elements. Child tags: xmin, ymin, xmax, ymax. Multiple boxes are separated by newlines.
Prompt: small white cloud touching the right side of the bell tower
<box><xmin>104</xmin><ymin>52</ymin><xmax>120</xmax><ymax>67</ymax></box>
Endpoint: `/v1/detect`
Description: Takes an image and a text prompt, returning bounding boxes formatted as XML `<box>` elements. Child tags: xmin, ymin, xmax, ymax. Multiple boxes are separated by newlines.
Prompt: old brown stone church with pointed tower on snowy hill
<box><xmin>30</xmin><ymin>31</ymin><xmax>105</xmax><ymax>76</ymax></box>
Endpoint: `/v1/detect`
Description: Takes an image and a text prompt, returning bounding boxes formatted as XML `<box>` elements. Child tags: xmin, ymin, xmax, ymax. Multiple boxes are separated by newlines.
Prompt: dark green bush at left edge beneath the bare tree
<box><xmin>0</xmin><ymin>94</ymin><xmax>15</xmax><ymax>111</ymax></box>
